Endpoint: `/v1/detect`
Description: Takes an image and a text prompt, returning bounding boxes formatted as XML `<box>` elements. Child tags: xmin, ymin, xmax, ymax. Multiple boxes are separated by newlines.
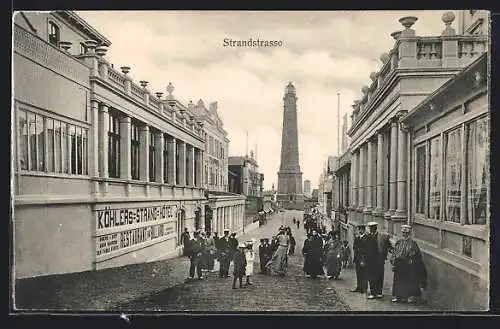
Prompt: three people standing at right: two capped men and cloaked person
<box><xmin>352</xmin><ymin>222</ymin><xmax>427</xmax><ymax>302</ymax></box>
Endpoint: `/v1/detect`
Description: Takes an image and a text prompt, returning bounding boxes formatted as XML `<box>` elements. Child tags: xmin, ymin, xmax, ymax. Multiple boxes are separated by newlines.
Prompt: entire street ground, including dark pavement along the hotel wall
<box><xmin>15</xmin><ymin>211</ymin><xmax>430</xmax><ymax>312</ymax></box>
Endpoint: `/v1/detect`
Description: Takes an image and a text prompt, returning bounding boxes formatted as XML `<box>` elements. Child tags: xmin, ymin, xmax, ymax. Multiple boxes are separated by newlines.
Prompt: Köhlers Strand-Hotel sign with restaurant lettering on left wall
<box><xmin>95</xmin><ymin>205</ymin><xmax>177</xmax><ymax>261</ymax></box>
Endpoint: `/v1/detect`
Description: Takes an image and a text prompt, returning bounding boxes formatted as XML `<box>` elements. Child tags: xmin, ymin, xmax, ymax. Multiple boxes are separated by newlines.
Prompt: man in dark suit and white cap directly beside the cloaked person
<box><xmin>365</xmin><ymin>222</ymin><xmax>392</xmax><ymax>299</ymax></box>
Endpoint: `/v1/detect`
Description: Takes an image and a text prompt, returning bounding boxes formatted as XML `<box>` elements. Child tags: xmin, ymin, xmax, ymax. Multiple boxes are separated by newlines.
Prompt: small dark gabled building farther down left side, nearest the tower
<box><xmin>229</xmin><ymin>151</ymin><xmax>264</xmax><ymax>226</ymax></box>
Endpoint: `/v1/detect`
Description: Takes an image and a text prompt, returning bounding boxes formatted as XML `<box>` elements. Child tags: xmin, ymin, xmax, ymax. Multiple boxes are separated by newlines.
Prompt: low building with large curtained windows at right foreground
<box><xmin>402</xmin><ymin>54</ymin><xmax>490</xmax><ymax>310</ymax></box>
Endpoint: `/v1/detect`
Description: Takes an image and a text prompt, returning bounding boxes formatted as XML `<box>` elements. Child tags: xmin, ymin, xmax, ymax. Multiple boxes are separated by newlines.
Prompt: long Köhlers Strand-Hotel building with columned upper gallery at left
<box><xmin>12</xmin><ymin>11</ymin><xmax>244</xmax><ymax>279</ymax></box>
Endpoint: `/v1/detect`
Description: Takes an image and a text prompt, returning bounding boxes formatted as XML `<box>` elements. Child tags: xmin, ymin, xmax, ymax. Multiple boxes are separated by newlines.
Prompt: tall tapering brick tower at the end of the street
<box><xmin>276</xmin><ymin>82</ymin><xmax>304</xmax><ymax>210</ymax></box>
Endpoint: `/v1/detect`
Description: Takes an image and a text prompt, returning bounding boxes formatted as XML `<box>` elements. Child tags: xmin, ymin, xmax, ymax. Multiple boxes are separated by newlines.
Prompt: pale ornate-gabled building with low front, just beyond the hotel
<box><xmin>188</xmin><ymin>99</ymin><xmax>245</xmax><ymax>233</ymax></box>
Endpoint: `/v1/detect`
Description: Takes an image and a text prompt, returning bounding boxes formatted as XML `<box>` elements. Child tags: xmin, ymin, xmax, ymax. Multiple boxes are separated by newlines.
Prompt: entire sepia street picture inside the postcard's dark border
<box><xmin>10</xmin><ymin>10</ymin><xmax>491</xmax><ymax>314</ymax></box>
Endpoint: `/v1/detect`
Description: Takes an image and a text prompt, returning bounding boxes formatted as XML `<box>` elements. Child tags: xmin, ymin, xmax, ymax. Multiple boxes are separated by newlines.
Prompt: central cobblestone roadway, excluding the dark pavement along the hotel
<box><xmin>115</xmin><ymin>211</ymin><xmax>430</xmax><ymax>312</ymax></box>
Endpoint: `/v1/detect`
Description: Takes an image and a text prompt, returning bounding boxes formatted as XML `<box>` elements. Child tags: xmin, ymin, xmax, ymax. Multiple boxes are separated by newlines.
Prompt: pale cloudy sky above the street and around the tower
<box><xmin>77</xmin><ymin>11</ymin><xmax>457</xmax><ymax>189</ymax></box>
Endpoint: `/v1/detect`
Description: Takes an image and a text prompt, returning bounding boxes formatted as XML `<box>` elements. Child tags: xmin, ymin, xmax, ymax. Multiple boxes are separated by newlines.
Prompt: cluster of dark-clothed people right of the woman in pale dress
<box><xmin>302</xmin><ymin>229</ymin><xmax>351</xmax><ymax>280</ymax></box>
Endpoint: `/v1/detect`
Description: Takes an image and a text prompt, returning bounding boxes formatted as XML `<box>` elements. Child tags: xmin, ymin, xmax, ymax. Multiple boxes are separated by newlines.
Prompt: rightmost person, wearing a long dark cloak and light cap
<box><xmin>390</xmin><ymin>225</ymin><xmax>427</xmax><ymax>303</ymax></box>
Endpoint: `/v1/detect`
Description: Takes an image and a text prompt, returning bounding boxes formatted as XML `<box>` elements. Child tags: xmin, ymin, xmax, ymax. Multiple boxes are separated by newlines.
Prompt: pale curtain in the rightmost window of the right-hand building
<box><xmin>466</xmin><ymin>117</ymin><xmax>490</xmax><ymax>225</ymax></box>
